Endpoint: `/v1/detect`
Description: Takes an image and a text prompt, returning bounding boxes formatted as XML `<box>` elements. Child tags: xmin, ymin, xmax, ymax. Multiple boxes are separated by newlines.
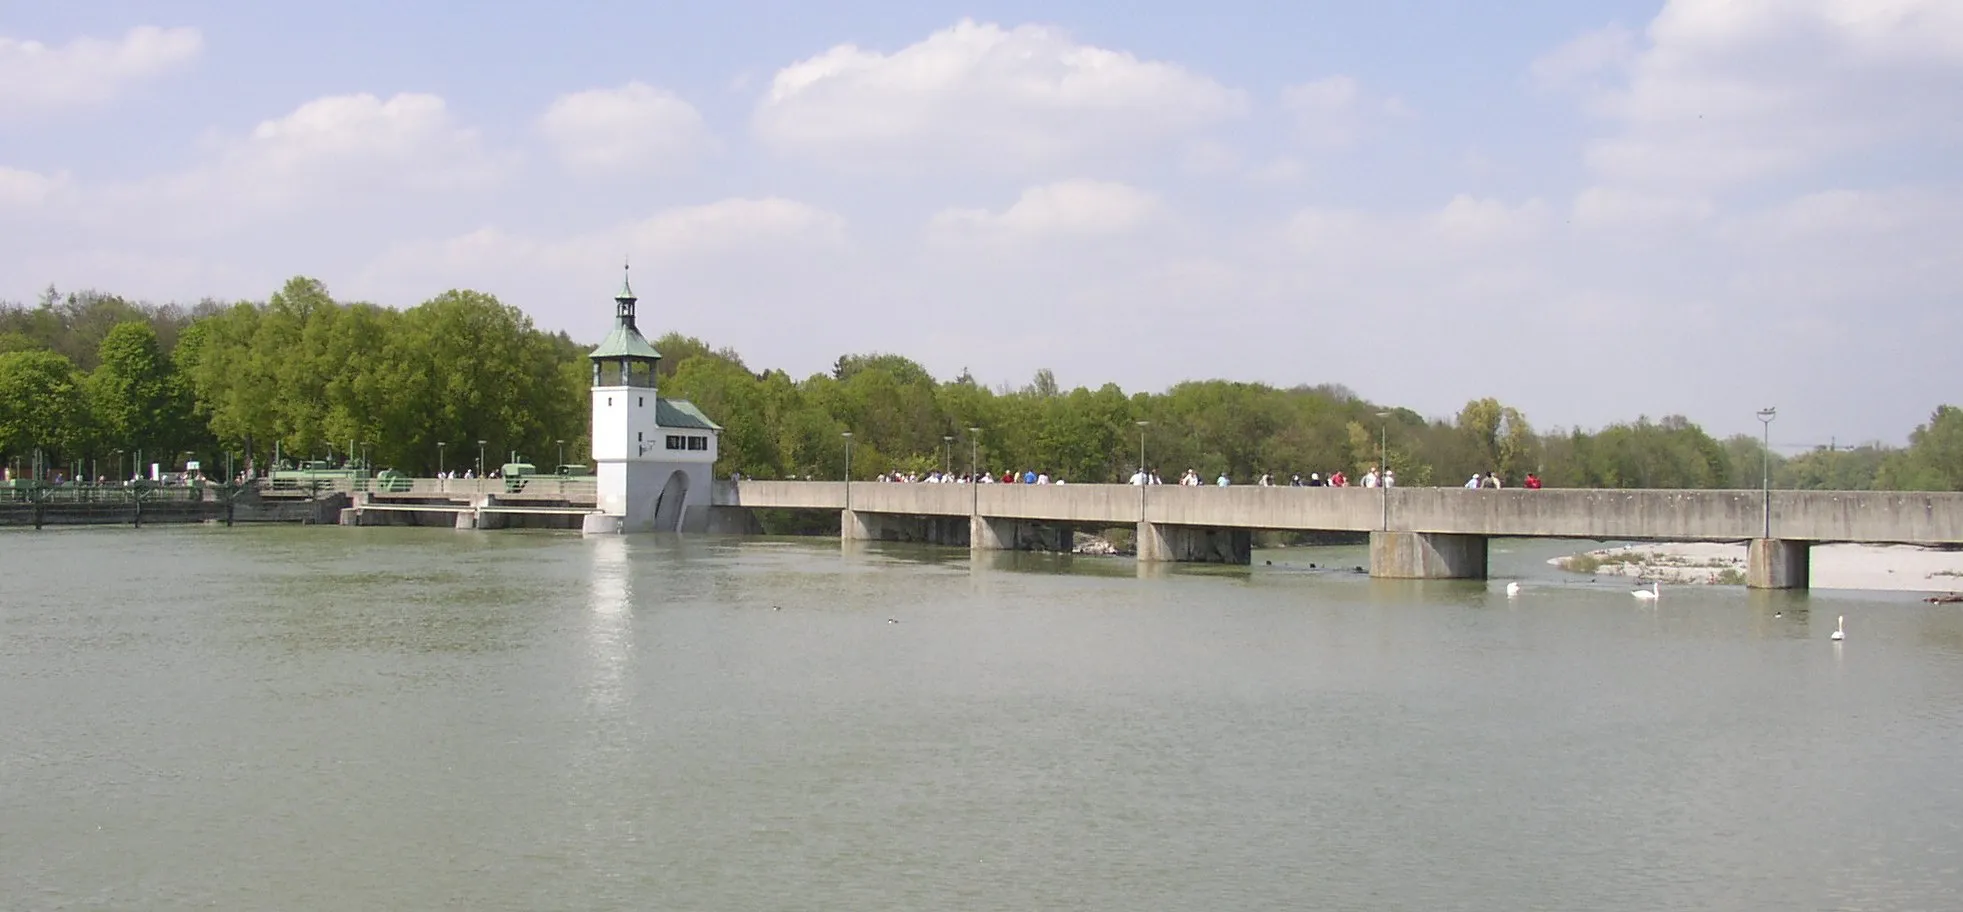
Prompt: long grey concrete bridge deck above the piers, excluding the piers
<box><xmin>713</xmin><ymin>481</ymin><xmax>1963</xmax><ymax>545</ymax></box>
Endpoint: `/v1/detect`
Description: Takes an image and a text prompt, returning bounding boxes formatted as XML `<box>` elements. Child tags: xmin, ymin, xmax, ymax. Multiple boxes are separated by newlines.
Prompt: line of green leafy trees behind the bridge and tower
<box><xmin>0</xmin><ymin>279</ymin><xmax>1963</xmax><ymax>490</ymax></box>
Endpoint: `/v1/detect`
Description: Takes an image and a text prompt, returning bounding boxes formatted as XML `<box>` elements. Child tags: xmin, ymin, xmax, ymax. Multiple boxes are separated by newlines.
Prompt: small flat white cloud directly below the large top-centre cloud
<box><xmin>930</xmin><ymin>180</ymin><xmax>1160</xmax><ymax>239</ymax></box>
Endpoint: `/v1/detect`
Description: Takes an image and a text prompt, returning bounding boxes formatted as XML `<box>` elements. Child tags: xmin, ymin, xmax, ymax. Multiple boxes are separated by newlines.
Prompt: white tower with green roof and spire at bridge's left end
<box><xmin>585</xmin><ymin>262</ymin><xmax>722</xmax><ymax>532</ymax></box>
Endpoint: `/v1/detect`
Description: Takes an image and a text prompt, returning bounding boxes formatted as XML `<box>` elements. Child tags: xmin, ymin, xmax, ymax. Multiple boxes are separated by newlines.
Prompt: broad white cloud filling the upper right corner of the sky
<box><xmin>1535</xmin><ymin>0</ymin><xmax>1963</xmax><ymax>188</ymax></box>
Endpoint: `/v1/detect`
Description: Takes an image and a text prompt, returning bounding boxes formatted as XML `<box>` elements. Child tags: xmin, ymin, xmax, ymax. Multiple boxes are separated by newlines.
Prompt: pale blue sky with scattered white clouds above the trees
<box><xmin>0</xmin><ymin>0</ymin><xmax>1963</xmax><ymax>451</ymax></box>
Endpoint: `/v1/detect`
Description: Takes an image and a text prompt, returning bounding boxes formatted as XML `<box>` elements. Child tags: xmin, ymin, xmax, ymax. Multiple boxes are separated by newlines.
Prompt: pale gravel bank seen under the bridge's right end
<box><xmin>1547</xmin><ymin>543</ymin><xmax>1963</xmax><ymax>592</ymax></box>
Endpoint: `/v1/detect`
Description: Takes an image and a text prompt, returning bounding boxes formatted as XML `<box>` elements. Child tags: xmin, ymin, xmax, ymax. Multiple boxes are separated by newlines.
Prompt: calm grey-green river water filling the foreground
<box><xmin>0</xmin><ymin>528</ymin><xmax>1963</xmax><ymax>912</ymax></box>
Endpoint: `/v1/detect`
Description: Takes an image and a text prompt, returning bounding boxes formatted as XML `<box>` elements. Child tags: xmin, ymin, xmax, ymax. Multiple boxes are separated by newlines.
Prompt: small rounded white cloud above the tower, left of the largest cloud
<box><xmin>538</xmin><ymin>82</ymin><xmax>711</xmax><ymax>173</ymax></box>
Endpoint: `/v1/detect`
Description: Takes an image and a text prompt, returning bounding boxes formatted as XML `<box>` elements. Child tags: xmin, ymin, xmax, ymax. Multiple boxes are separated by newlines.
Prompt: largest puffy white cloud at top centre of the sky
<box><xmin>754</xmin><ymin>20</ymin><xmax>1247</xmax><ymax>169</ymax></box>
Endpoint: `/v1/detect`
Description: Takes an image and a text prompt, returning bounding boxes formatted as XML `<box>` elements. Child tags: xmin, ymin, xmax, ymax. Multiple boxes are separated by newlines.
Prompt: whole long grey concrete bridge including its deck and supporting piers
<box><xmin>711</xmin><ymin>481</ymin><xmax>1963</xmax><ymax>588</ymax></box>
